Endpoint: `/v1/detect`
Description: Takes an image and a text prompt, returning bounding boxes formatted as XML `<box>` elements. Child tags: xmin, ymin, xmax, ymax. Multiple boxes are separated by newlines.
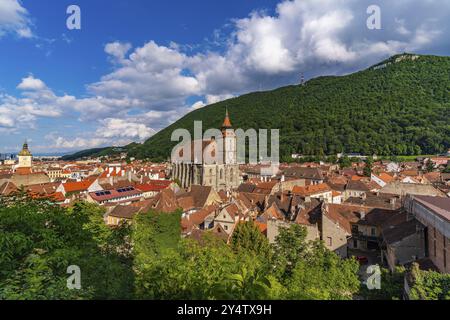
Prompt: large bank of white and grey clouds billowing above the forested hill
<box><xmin>0</xmin><ymin>0</ymin><xmax>450</xmax><ymax>148</ymax></box>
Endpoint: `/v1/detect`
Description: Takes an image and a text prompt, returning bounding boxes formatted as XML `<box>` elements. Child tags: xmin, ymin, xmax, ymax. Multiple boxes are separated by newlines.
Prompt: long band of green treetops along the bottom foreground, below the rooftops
<box><xmin>0</xmin><ymin>199</ymin><xmax>358</xmax><ymax>300</ymax></box>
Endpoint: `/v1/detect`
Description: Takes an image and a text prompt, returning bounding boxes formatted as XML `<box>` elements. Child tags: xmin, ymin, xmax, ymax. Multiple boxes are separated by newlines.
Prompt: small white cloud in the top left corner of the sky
<box><xmin>0</xmin><ymin>0</ymin><xmax>33</xmax><ymax>38</ymax></box>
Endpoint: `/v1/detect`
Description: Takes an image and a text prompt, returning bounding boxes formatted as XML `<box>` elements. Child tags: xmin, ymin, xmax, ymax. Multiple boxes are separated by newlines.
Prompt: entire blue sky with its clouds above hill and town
<box><xmin>0</xmin><ymin>0</ymin><xmax>450</xmax><ymax>153</ymax></box>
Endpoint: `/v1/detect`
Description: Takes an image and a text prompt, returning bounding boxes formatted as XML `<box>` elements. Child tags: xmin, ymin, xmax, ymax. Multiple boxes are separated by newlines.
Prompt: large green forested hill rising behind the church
<box><xmin>64</xmin><ymin>54</ymin><xmax>450</xmax><ymax>160</ymax></box>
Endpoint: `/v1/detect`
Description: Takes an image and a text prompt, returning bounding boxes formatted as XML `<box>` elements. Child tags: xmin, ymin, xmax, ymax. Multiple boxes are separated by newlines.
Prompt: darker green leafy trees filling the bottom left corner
<box><xmin>0</xmin><ymin>199</ymin><xmax>134</xmax><ymax>300</ymax></box>
